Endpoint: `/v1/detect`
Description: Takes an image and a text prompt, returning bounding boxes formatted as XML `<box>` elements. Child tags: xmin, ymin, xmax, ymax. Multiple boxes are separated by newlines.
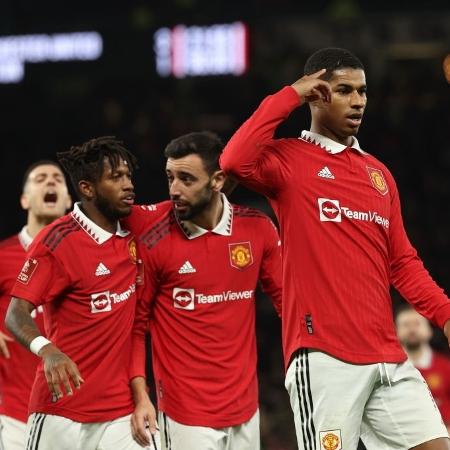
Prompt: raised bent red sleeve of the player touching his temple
<box><xmin>220</xmin><ymin>86</ymin><xmax>300</xmax><ymax>197</ymax></box>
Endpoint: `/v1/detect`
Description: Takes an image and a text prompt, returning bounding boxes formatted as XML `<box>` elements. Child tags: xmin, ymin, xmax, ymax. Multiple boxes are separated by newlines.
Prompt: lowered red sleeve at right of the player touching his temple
<box><xmin>389</xmin><ymin>179</ymin><xmax>450</xmax><ymax>328</ymax></box>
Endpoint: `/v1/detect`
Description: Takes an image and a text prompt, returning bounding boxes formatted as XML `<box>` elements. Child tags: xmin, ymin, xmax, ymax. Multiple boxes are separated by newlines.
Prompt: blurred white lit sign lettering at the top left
<box><xmin>0</xmin><ymin>31</ymin><xmax>103</xmax><ymax>83</ymax></box>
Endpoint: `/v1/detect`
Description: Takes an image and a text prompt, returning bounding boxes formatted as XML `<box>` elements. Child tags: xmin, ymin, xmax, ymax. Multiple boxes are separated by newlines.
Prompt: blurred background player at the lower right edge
<box><xmin>395</xmin><ymin>305</ymin><xmax>450</xmax><ymax>429</ymax></box>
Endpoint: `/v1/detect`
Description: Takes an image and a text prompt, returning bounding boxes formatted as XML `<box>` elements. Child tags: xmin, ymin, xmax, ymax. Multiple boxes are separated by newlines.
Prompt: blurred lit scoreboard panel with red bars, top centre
<box><xmin>154</xmin><ymin>22</ymin><xmax>248</xmax><ymax>78</ymax></box>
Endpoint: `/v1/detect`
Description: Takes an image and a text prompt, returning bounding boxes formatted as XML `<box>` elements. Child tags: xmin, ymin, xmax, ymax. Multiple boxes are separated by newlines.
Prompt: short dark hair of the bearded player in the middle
<box><xmin>164</xmin><ymin>131</ymin><xmax>224</xmax><ymax>175</ymax></box>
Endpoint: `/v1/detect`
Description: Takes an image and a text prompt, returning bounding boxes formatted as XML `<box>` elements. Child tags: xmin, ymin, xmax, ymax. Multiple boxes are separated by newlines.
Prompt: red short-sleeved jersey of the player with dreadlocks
<box><xmin>12</xmin><ymin>204</ymin><xmax>138</xmax><ymax>422</ymax></box>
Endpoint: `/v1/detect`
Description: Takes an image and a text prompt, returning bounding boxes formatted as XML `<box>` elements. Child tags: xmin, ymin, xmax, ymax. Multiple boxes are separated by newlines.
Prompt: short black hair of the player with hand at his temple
<box><xmin>304</xmin><ymin>47</ymin><xmax>364</xmax><ymax>80</ymax></box>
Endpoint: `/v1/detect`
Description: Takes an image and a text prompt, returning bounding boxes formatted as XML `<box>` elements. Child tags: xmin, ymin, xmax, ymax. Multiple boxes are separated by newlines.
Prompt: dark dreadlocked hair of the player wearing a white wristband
<box><xmin>56</xmin><ymin>136</ymin><xmax>138</xmax><ymax>192</ymax></box>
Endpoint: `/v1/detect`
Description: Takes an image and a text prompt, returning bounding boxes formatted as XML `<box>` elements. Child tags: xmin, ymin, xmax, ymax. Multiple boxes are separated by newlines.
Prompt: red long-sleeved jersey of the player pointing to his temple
<box><xmin>221</xmin><ymin>86</ymin><xmax>450</xmax><ymax>366</ymax></box>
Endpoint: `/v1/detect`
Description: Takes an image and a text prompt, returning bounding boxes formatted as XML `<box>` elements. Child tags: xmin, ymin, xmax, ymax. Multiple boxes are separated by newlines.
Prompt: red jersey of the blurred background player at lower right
<box><xmin>416</xmin><ymin>349</ymin><xmax>450</xmax><ymax>425</ymax></box>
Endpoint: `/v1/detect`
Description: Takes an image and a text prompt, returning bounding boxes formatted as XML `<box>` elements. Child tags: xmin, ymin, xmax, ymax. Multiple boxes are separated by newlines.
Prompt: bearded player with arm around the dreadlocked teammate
<box><xmin>127</xmin><ymin>132</ymin><xmax>281</xmax><ymax>450</ymax></box>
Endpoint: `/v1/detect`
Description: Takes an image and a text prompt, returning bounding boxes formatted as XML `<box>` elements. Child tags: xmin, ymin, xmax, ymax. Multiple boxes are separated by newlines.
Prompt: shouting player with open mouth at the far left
<box><xmin>0</xmin><ymin>160</ymin><xmax>71</xmax><ymax>450</ymax></box>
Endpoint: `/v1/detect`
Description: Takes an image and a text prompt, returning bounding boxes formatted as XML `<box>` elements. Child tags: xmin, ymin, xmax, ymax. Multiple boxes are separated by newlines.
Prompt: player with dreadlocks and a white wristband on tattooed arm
<box><xmin>6</xmin><ymin>137</ymin><xmax>156</xmax><ymax>450</ymax></box>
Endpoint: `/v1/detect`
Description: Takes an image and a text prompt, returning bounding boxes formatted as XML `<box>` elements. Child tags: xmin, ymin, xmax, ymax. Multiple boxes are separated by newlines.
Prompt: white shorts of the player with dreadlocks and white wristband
<box><xmin>26</xmin><ymin>413</ymin><xmax>160</xmax><ymax>450</ymax></box>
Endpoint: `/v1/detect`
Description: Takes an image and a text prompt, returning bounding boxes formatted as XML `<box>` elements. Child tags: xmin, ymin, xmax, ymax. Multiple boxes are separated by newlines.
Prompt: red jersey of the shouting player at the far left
<box><xmin>0</xmin><ymin>227</ymin><xmax>45</xmax><ymax>422</ymax></box>
